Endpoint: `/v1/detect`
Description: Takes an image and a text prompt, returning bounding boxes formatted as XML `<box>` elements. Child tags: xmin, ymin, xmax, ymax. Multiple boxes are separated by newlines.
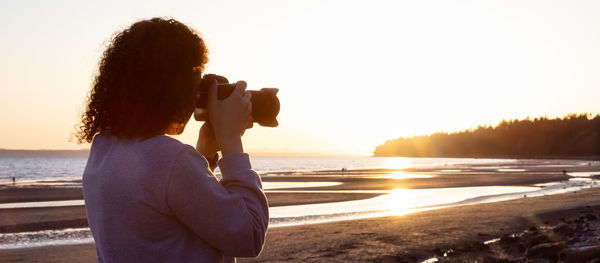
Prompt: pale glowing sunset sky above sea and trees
<box><xmin>0</xmin><ymin>0</ymin><xmax>600</xmax><ymax>156</ymax></box>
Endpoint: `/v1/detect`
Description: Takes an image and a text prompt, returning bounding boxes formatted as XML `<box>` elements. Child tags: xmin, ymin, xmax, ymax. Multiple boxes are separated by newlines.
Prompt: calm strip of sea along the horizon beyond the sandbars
<box><xmin>0</xmin><ymin>156</ymin><xmax>517</xmax><ymax>181</ymax></box>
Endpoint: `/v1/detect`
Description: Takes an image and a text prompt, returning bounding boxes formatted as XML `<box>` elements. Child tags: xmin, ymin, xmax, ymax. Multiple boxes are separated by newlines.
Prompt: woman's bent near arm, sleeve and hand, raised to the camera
<box><xmin>180</xmin><ymin>80</ymin><xmax>269</xmax><ymax>256</ymax></box>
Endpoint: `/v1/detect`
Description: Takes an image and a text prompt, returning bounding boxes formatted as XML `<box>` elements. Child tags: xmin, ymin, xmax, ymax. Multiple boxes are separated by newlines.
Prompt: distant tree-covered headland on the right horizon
<box><xmin>374</xmin><ymin>114</ymin><xmax>600</xmax><ymax>158</ymax></box>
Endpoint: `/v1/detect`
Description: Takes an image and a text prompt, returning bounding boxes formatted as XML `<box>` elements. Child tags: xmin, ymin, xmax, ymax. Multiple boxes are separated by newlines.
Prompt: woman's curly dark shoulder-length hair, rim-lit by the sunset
<box><xmin>76</xmin><ymin>18</ymin><xmax>208</xmax><ymax>143</ymax></box>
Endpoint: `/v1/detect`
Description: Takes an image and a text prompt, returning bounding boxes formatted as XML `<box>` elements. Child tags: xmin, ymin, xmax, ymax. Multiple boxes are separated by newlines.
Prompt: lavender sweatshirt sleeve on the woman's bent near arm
<box><xmin>167</xmin><ymin>147</ymin><xmax>269</xmax><ymax>256</ymax></box>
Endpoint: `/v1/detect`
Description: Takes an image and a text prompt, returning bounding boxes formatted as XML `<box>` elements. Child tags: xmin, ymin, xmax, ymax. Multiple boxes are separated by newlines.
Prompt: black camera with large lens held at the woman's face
<box><xmin>194</xmin><ymin>74</ymin><xmax>279</xmax><ymax>127</ymax></box>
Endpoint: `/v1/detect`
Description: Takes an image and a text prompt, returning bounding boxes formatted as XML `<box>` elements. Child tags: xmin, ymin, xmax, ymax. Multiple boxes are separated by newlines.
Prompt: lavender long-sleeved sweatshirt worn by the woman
<box><xmin>83</xmin><ymin>135</ymin><xmax>269</xmax><ymax>262</ymax></box>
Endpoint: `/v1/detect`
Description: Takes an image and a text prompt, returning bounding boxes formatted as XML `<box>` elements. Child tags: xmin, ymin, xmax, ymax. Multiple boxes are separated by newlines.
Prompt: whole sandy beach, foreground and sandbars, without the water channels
<box><xmin>0</xmin><ymin>166</ymin><xmax>600</xmax><ymax>262</ymax></box>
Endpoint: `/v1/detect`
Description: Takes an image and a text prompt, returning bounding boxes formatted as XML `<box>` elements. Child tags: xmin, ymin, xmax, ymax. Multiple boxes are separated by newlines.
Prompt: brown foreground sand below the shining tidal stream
<box><xmin>0</xmin><ymin>189</ymin><xmax>600</xmax><ymax>262</ymax></box>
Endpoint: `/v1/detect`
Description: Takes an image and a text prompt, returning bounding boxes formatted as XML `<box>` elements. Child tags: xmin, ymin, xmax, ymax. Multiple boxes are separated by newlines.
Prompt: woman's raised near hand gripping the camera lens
<box><xmin>206</xmin><ymin>80</ymin><xmax>252</xmax><ymax>156</ymax></box>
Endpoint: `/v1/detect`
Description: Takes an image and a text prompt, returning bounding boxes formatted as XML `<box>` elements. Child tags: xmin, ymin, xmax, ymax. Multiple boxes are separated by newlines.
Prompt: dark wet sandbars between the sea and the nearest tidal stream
<box><xmin>0</xmin><ymin>170</ymin><xmax>569</xmax><ymax>233</ymax></box>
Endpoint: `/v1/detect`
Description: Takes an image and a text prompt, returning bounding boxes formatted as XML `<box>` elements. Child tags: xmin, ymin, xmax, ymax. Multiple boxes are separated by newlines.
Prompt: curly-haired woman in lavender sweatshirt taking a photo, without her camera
<box><xmin>78</xmin><ymin>18</ymin><xmax>268</xmax><ymax>262</ymax></box>
